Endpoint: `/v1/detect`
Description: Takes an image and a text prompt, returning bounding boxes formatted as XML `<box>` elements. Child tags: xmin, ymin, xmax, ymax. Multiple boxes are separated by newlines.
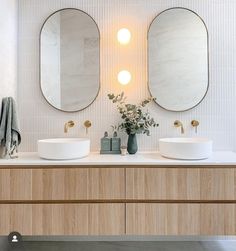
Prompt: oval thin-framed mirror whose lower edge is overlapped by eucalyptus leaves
<box><xmin>148</xmin><ymin>8</ymin><xmax>209</xmax><ymax>111</ymax></box>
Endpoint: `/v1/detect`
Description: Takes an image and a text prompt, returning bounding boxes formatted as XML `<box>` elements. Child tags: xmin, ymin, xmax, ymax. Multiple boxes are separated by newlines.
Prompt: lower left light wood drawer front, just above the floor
<box><xmin>0</xmin><ymin>204</ymin><xmax>125</xmax><ymax>235</ymax></box>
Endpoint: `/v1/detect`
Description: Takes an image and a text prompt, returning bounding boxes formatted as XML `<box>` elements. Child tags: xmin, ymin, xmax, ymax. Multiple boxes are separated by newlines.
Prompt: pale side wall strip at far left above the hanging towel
<box><xmin>0</xmin><ymin>0</ymin><xmax>18</xmax><ymax>105</ymax></box>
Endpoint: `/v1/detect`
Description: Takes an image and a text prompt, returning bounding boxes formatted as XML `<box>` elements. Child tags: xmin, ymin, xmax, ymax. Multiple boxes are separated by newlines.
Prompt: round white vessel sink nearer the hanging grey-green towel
<box><xmin>38</xmin><ymin>138</ymin><xmax>90</xmax><ymax>160</ymax></box>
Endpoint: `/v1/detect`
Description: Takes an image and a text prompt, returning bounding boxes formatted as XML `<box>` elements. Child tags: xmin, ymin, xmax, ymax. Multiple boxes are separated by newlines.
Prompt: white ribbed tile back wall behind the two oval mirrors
<box><xmin>18</xmin><ymin>0</ymin><xmax>236</xmax><ymax>151</ymax></box>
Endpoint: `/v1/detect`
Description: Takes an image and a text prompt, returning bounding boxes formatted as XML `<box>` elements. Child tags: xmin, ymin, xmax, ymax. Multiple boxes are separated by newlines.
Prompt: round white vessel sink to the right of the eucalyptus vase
<box><xmin>159</xmin><ymin>138</ymin><xmax>212</xmax><ymax>160</ymax></box>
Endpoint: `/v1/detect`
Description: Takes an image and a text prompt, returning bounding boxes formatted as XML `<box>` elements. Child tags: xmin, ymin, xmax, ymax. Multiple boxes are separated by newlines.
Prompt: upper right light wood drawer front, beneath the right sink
<box><xmin>126</xmin><ymin>167</ymin><xmax>236</xmax><ymax>200</ymax></box>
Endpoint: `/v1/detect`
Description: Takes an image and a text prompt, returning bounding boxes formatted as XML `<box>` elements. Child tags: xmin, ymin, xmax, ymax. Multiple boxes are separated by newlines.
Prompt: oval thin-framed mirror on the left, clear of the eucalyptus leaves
<box><xmin>40</xmin><ymin>8</ymin><xmax>100</xmax><ymax>112</ymax></box>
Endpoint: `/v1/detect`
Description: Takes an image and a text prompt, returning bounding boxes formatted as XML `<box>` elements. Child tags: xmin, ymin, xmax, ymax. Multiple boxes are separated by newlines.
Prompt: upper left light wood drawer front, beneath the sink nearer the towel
<box><xmin>0</xmin><ymin>167</ymin><xmax>125</xmax><ymax>200</ymax></box>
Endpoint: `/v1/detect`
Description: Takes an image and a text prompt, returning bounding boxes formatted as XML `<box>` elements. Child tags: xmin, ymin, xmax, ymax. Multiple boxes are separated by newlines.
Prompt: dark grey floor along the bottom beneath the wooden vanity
<box><xmin>0</xmin><ymin>237</ymin><xmax>236</xmax><ymax>251</ymax></box>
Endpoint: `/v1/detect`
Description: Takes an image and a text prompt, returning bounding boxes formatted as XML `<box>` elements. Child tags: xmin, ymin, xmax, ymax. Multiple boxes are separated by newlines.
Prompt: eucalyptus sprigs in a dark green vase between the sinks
<box><xmin>108</xmin><ymin>92</ymin><xmax>158</xmax><ymax>154</ymax></box>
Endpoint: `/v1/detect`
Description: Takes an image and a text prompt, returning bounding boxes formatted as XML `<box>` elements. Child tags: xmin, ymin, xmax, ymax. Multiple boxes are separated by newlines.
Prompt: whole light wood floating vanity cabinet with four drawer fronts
<box><xmin>0</xmin><ymin>165</ymin><xmax>236</xmax><ymax>235</ymax></box>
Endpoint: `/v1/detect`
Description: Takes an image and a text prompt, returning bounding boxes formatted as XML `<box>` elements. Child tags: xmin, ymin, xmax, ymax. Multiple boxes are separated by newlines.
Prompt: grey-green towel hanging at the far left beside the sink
<box><xmin>0</xmin><ymin>97</ymin><xmax>21</xmax><ymax>157</ymax></box>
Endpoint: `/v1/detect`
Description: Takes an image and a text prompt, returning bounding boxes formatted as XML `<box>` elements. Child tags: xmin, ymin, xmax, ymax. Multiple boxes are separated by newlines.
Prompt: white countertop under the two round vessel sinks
<box><xmin>0</xmin><ymin>151</ymin><xmax>236</xmax><ymax>168</ymax></box>
